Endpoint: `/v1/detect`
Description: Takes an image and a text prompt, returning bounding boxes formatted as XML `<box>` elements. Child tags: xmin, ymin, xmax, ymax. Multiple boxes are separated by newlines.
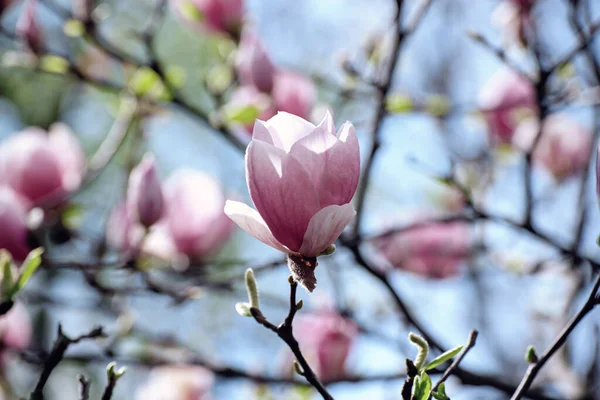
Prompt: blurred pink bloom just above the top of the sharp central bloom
<box><xmin>272</xmin><ymin>70</ymin><xmax>317</xmax><ymax>119</ymax></box>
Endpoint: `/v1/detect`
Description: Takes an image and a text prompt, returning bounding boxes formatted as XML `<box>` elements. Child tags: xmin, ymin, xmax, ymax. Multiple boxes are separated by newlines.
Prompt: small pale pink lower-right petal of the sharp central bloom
<box><xmin>299</xmin><ymin>204</ymin><xmax>356</xmax><ymax>257</ymax></box>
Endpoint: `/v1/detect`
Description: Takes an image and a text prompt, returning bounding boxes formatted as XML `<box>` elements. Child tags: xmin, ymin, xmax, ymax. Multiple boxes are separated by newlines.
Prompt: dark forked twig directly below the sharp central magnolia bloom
<box><xmin>250</xmin><ymin>276</ymin><xmax>333</xmax><ymax>400</ymax></box>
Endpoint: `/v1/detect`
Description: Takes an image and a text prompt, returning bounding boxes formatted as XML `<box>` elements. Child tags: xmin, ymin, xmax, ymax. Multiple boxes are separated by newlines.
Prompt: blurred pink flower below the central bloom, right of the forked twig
<box><xmin>285</xmin><ymin>311</ymin><xmax>358</xmax><ymax>382</ymax></box>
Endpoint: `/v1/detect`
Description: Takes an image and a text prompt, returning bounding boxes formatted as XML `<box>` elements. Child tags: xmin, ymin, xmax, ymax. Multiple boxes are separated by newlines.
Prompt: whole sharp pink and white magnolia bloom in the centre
<box><xmin>225</xmin><ymin>112</ymin><xmax>360</xmax><ymax>257</ymax></box>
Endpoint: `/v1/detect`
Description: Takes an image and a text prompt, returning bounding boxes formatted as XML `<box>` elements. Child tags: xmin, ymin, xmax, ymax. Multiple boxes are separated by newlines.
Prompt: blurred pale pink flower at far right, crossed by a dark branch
<box><xmin>514</xmin><ymin>114</ymin><xmax>593</xmax><ymax>180</ymax></box>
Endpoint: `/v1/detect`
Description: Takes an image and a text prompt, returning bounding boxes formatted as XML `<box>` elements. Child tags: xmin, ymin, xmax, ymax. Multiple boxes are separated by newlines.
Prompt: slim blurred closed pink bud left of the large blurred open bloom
<box><xmin>127</xmin><ymin>154</ymin><xmax>164</xmax><ymax>227</ymax></box>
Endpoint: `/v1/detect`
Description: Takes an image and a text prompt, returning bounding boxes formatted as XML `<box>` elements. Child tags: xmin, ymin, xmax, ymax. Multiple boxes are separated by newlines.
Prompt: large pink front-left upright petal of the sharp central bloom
<box><xmin>246</xmin><ymin>140</ymin><xmax>320</xmax><ymax>251</ymax></box>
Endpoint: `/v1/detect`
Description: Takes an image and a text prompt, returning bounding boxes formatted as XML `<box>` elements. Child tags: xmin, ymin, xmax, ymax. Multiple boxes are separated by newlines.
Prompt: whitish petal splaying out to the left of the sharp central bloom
<box><xmin>225</xmin><ymin>200</ymin><xmax>289</xmax><ymax>253</ymax></box>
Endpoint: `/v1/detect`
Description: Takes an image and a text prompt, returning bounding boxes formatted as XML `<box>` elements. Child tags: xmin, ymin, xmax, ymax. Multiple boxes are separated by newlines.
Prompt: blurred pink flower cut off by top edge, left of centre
<box><xmin>171</xmin><ymin>0</ymin><xmax>244</xmax><ymax>36</ymax></box>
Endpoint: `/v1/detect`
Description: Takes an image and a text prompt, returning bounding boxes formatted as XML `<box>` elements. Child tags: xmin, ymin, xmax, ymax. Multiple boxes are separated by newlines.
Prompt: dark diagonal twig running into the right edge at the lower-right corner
<box><xmin>511</xmin><ymin>273</ymin><xmax>600</xmax><ymax>400</ymax></box>
